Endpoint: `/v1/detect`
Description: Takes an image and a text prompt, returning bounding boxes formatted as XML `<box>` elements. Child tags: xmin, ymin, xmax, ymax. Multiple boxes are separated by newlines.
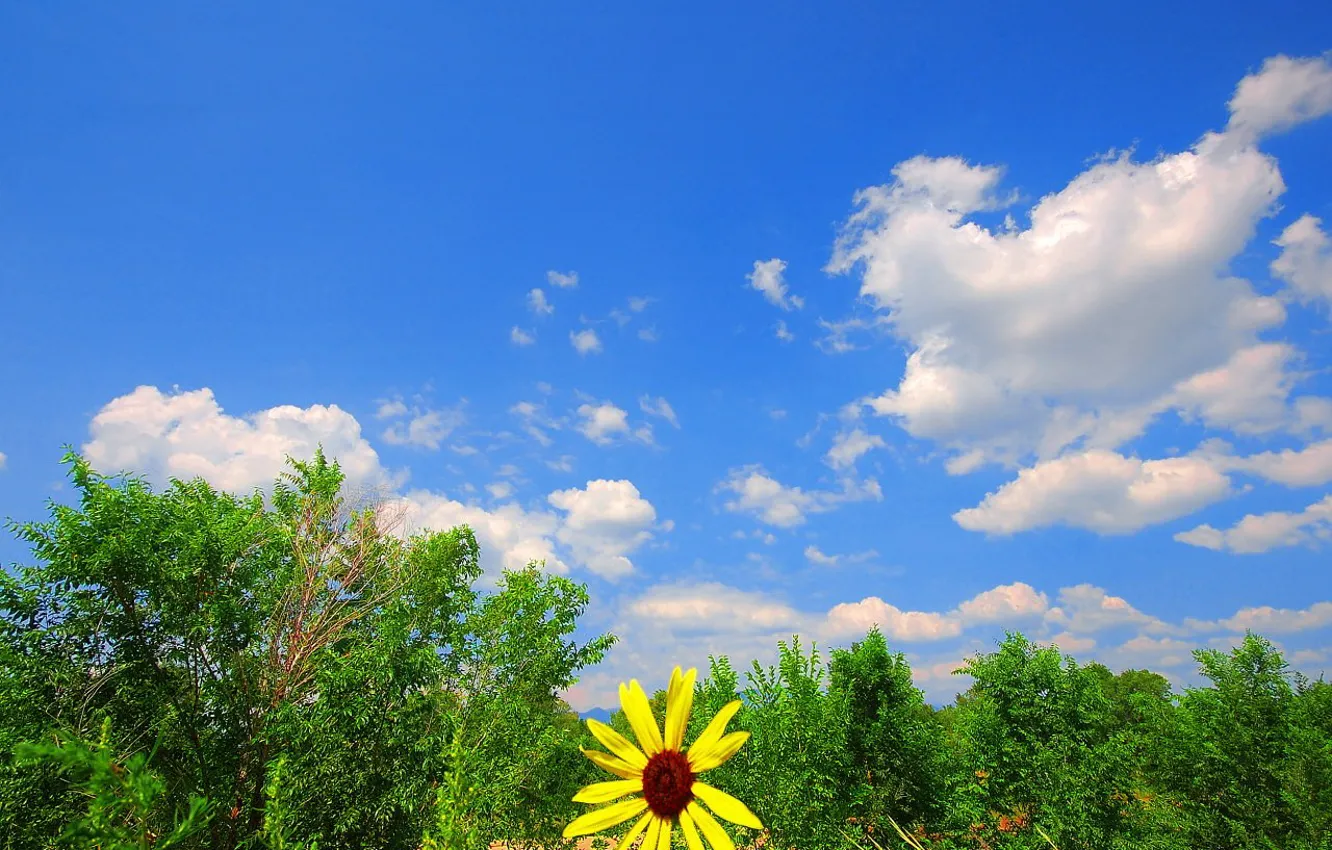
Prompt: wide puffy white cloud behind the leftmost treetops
<box><xmin>83</xmin><ymin>386</ymin><xmax>393</xmax><ymax>493</ymax></box>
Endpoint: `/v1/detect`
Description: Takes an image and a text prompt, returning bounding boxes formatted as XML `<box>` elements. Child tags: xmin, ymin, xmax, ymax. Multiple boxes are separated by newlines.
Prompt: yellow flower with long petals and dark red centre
<box><xmin>565</xmin><ymin>667</ymin><xmax>763</xmax><ymax>850</ymax></box>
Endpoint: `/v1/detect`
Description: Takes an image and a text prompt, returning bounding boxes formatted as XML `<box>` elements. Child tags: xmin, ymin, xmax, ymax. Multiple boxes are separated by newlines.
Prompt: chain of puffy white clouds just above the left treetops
<box><xmin>83</xmin><ymin>386</ymin><xmax>667</xmax><ymax>581</ymax></box>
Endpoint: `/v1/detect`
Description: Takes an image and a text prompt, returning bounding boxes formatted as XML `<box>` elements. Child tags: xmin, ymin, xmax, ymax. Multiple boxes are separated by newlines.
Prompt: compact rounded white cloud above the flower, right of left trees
<box><xmin>547</xmin><ymin>480</ymin><xmax>657</xmax><ymax>578</ymax></box>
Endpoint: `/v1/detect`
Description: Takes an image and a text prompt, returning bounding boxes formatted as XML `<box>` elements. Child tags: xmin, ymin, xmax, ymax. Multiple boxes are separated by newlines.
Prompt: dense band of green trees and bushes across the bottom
<box><xmin>0</xmin><ymin>454</ymin><xmax>1332</xmax><ymax>850</ymax></box>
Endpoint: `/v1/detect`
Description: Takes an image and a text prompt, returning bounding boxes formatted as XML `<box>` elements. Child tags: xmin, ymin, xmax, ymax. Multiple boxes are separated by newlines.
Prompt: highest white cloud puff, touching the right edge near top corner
<box><xmin>1228</xmin><ymin>56</ymin><xmax>1332</xmax><ymax>137</ymax></box>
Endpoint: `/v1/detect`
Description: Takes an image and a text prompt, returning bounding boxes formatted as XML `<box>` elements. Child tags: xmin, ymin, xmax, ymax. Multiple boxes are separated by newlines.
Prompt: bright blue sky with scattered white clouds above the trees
<box><xmin>0</xmin><ymin>3</ymin><xmax>1332</xmax><ymax>709</ymax></box>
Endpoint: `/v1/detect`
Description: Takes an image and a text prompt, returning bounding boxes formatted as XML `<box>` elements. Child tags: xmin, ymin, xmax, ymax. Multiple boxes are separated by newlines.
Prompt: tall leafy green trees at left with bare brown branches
<box><xmin>0</xmin><ymin>453</ymin><xmax>613</xmax><ymax>850</ymax></box>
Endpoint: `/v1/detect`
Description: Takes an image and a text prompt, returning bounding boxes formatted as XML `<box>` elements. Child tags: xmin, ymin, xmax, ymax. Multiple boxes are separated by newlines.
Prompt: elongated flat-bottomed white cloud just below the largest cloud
<box><xmin>952</xmin><ymin>450</ymin><xmax>1231</xmax><ymax>534</ymax></box>
